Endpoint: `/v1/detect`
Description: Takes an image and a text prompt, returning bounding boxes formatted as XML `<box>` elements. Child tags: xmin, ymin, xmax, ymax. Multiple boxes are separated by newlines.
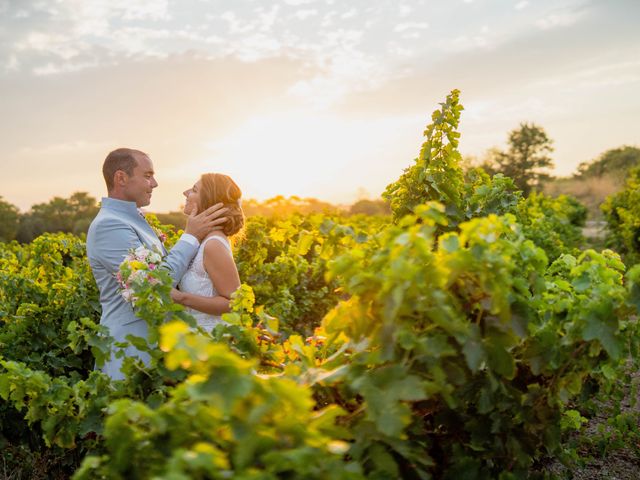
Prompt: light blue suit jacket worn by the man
<box><xmin>87</xmin><ymin>198</ymin><xmax>198</xmax><ymax>380</ymax></box>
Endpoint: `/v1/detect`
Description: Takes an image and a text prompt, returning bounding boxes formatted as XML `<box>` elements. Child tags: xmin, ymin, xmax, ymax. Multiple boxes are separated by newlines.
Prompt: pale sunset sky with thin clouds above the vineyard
<box><xmin>0</xmin><ymin>0</ymin><xmax>640</xmax><ymax>211</ymax></box>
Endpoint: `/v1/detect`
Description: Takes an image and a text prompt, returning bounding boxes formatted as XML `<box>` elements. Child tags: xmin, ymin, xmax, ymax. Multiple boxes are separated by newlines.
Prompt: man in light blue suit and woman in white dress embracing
<box><xmin>87</xmin><ymin>148</ymin><xmax>244</xmax><ymax>380</ymax></box>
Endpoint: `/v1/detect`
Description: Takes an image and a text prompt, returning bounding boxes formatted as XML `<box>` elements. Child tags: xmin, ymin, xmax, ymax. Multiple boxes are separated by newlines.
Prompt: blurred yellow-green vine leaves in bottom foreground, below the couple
<box><xmin>74</xmin><ymin>321</ymin><xmax>362</xmax><ymax>479</ymax></box>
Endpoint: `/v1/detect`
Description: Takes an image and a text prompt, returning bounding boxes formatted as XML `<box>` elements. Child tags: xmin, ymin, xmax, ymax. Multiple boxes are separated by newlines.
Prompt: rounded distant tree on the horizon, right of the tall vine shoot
<box><xmin>482</xmin><ymin>123</ymin><xmax>553</xmax><ymax>196</ymax></box>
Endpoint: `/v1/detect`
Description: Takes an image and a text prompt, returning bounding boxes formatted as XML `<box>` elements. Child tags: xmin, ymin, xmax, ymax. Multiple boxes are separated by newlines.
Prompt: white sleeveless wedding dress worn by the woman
<box><xmin>178</xmin><ymin>235</ymin><xmax>233</xmax><ymax>332</ymax></box>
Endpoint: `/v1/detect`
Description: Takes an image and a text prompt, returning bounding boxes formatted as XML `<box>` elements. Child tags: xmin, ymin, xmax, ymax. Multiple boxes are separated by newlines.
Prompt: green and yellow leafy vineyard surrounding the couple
<box><xmin>0</xmin><ymin>90</ymin><xmax>640</xmax><ymax>480</ymax></box>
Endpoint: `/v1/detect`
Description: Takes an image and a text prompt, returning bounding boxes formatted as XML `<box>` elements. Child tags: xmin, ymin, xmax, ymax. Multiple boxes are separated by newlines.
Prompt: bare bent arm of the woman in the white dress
<box><xmin>171</xmin><ymin>236</ymin><xmax>240</xmax><ymax>315</ymax></box>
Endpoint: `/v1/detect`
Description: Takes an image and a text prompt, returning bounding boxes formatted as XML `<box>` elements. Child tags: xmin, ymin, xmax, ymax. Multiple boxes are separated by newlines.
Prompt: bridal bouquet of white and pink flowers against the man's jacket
<box><xmin>116</xmin><ymin>245</ymin><xmax>162</xmax><ymax>306</ymax></box>
